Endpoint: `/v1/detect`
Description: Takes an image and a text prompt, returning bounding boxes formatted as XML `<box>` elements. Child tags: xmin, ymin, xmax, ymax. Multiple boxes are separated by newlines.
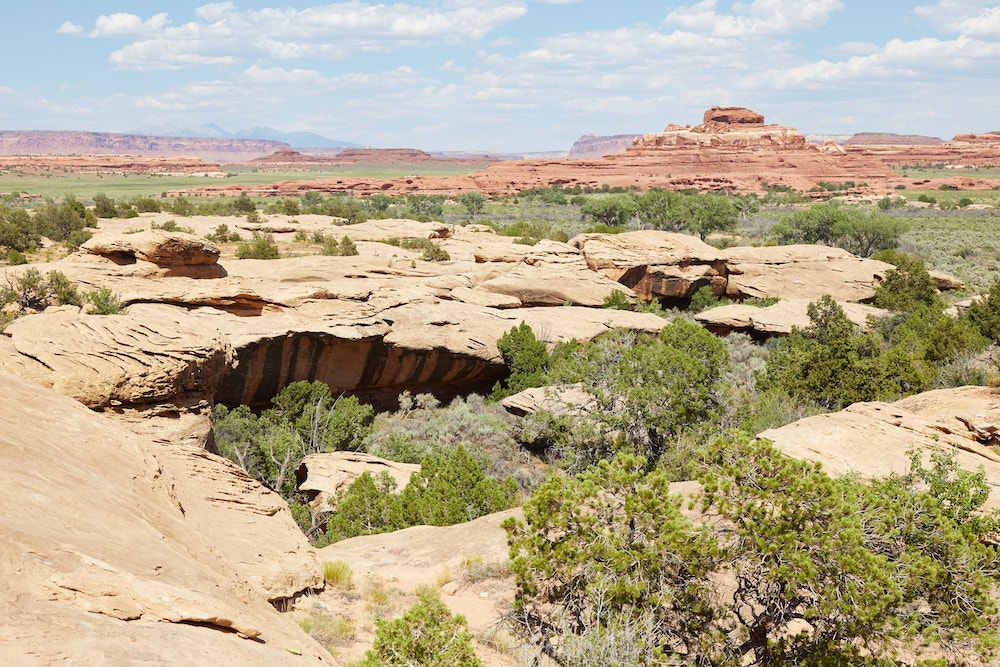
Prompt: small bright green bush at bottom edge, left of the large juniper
<box><xmin>358</xmin><ymin>594</ymin><xmax>483</xmax><ymax>667</ymax></box>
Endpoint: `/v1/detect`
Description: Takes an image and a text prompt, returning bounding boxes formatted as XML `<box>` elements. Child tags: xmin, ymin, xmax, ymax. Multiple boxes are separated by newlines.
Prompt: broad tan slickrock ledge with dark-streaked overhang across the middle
<box><xmin>0</xmin><ymin>216</ymin><xmax>916</xmax><ymax>420</ymax></box>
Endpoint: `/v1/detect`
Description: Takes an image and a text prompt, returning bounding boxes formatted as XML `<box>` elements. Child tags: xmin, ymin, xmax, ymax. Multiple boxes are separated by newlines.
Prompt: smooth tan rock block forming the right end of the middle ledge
<box><xmin>721</xmin><ymin>245</ymin><xmax>893</xmax><ymax>301</ymax></box>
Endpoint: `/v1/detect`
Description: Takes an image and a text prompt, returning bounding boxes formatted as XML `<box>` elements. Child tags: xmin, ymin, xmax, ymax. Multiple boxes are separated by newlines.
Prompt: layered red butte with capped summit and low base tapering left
<box><xmin>170</xmin><ymin>107</ymin><xmax>899</xmax><ymax>196</ymax></box>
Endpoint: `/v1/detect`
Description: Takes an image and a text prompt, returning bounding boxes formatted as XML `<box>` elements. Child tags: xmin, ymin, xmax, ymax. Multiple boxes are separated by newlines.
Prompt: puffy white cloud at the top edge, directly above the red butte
<box><xmin>664</xmin><ymin>0</ymin><xmax>844</xmax><ymax>37</ymax></box>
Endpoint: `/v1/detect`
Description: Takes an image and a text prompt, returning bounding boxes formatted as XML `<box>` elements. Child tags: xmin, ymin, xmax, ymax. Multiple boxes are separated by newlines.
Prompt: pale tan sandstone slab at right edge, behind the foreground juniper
<box><xmin>760</xmin><ymin>387</ymin><xmax>1000</xmax><ymax>509</ymax></box>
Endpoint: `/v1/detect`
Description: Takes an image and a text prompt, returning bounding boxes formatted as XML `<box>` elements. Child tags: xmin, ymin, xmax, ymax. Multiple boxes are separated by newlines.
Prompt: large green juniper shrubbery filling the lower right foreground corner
<box><xmin>504</xmin><ymin>438</ymin><xmax>997</xmax><ymax>665</ymax></box>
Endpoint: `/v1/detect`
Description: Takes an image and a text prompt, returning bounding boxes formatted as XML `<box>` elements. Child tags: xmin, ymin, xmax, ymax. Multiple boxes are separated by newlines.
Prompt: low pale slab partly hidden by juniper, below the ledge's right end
<box><xmin>694</xmin><ymin>299</ymin><xmax>889</xmax><ymax>338</ymax></box>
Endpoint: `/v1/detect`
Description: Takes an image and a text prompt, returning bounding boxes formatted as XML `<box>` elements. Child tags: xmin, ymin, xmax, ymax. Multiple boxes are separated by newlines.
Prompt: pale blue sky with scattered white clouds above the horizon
<box><xmin>0</xmin><ymin>0</ymin><xmax>1000</xmax><ymax>152</ymax></box>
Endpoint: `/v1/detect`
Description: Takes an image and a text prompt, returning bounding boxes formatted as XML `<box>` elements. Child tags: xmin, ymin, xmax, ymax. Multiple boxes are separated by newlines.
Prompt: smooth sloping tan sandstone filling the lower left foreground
<box><xmin>0</xmin><ymin>374</ymin><xmax>336</xmax><ymax>667</ymax></box>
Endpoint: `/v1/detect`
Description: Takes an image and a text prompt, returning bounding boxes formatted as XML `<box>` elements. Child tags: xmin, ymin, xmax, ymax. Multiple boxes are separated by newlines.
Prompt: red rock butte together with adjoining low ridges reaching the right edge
<box><xmin>162</xmin><ymin>107</ymin><xmax>1000</xmax><ymax>197</ymax></box>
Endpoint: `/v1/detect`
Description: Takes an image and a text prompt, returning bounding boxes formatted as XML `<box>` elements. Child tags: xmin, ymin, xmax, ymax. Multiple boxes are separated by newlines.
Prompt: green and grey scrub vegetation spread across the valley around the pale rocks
<box><xmin>7</xmin><ymin>180</ymin><xmax>1000</xmax><ymax>666</ymax></box>
